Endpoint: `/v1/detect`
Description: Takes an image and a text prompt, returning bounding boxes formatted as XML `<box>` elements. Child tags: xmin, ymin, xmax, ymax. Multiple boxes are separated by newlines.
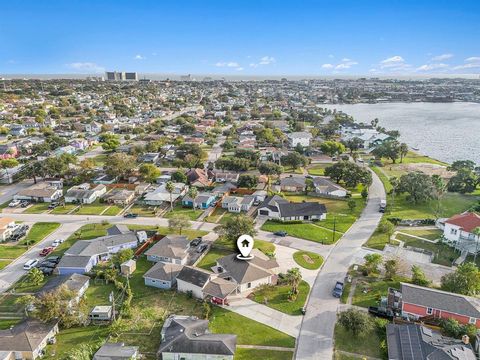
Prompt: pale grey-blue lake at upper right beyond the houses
<box><xmin>324</xmin><ymin>102</ymin><xmax>480</xmax><ymax>164</ymax></box>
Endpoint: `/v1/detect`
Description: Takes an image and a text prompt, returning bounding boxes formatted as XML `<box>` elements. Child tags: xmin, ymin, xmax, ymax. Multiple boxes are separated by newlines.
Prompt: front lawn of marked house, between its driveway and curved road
<box><xmin>252</xmin><ymin>281</ymin><xmax>310</xmax><ymax>315</ymax></box>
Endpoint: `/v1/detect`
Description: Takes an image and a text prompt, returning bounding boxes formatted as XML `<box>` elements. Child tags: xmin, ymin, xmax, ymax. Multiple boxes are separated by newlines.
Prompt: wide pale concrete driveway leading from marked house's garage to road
<box><xmin>225</xmin><ymin>298</ymin><xmax>302</xmax><ymax>338</ymax></box>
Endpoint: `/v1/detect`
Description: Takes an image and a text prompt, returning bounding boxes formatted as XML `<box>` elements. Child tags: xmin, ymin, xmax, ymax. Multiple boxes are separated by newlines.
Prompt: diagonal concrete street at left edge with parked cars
<box><xmin>0</xmin><ymin>224</ymin><xmax>83</xmax><ymax>294</ymax></box>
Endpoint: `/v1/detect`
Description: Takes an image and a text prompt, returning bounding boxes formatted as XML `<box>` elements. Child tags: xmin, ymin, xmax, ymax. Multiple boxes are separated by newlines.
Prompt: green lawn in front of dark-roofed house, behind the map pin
<box><xmin>262</xmin><ymin>220</ymin><xmax>342</xmax><ymax>244</ymax></box>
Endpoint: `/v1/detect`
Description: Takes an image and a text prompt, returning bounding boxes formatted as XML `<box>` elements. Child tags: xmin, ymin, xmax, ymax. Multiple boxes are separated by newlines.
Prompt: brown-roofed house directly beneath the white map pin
<box><xmin>215</xmin><ymin>249</ymin><xmax>279</xmax><ymax>293</ymax></box>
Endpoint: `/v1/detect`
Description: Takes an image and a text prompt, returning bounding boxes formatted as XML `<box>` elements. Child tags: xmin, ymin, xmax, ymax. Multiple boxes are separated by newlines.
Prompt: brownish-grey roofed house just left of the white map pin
<box><xmin>145</xmin><ymin>235</ymin><xmax>190</xmax><ymax>265</ymax></box>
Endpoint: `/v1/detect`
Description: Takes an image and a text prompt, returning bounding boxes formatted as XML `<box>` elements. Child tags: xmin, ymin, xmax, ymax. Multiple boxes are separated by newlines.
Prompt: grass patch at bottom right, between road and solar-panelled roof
<box><xmin>334</xmin><ymin>323</ymin><xmax>383</xmax><ymax>359</ymax></box>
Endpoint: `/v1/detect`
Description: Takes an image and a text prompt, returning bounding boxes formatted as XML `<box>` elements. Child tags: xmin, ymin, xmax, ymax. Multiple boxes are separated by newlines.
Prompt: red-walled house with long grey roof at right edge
<box><xmin>388</xmin><ymin>283</ymin><xmax>480</xmax><ymax>328</ymax></box>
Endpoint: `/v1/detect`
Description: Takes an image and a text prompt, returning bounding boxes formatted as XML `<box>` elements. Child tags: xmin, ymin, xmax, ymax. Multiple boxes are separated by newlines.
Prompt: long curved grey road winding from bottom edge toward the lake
<box><xmin>295</xmin><ymin>171</ymin><xmax>386</xmax><ymax>360</ymax></box>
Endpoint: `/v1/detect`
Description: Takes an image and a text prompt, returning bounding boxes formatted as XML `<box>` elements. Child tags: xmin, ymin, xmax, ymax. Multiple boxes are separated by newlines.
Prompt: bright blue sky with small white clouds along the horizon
<box><xmin>0</xmin><ymin>0</ymin><xmax>480</xmax><ymax>75</ymax></box>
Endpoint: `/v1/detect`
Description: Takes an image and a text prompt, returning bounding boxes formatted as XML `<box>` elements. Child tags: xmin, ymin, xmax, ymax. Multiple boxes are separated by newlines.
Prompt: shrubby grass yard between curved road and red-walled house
<box><xmin>352</xmin><ymin>276</ymin><xmax>408</xmax><ymax>307</ymax></box>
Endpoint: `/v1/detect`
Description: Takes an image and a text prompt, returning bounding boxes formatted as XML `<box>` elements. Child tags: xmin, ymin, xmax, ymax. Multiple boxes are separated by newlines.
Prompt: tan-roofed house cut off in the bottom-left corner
<box><xmin>0</xmin><ymin>319</ymin><xmax>58</xmax><ymax>360</ymax></box>
